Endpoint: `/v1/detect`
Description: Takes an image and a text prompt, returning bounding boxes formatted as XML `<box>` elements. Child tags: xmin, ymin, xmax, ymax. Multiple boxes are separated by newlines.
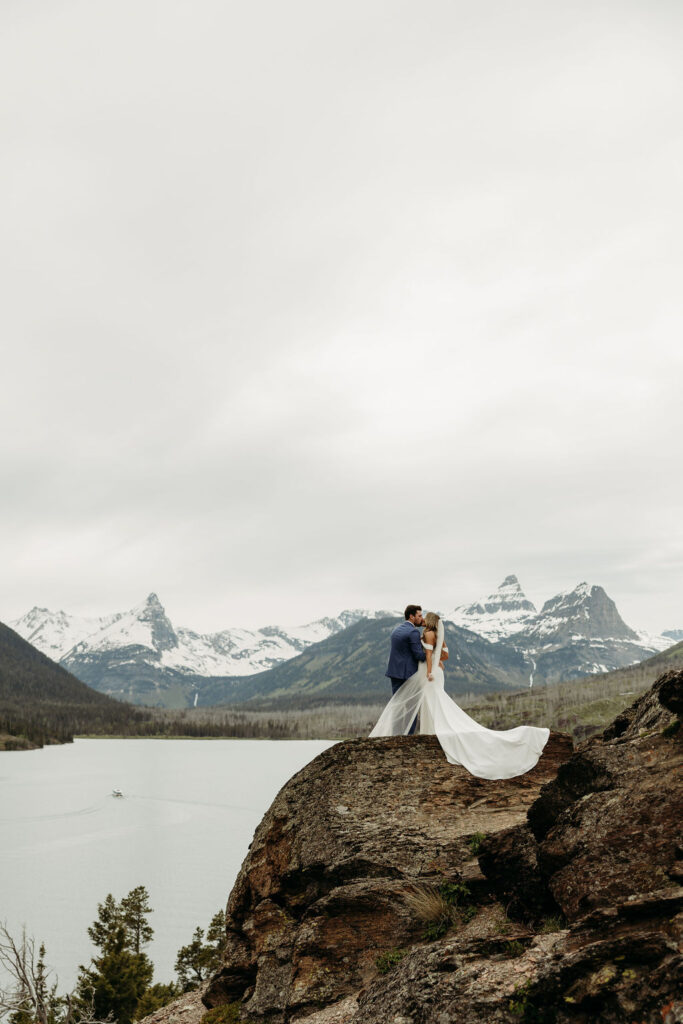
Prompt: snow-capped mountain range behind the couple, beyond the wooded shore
<box><xmin>10</xmin><ymin>575</ymin><xmax>677</xmax><ymax>708</ymax></box>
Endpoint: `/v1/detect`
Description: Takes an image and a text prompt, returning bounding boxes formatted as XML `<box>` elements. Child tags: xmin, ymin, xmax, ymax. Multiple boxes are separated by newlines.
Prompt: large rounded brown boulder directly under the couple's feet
<box><xmin>205</xmin><ymin>734</ymin><xmax>571</xmax><ymax>1020</ymax></box>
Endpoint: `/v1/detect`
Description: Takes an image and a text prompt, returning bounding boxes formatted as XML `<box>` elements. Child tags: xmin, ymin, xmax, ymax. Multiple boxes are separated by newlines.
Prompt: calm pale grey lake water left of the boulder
<box><xmin>0</xmin><ymin>739</ymin><xmax>331</xmax><ymax>991</ymax></box>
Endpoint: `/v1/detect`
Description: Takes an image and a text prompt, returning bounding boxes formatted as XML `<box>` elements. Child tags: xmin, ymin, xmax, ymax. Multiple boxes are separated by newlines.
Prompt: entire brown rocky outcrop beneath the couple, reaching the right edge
<box><xmin>152</xmin><ymin>672</ymin><xmax>683</xmax><ymax>1024</ymax></box>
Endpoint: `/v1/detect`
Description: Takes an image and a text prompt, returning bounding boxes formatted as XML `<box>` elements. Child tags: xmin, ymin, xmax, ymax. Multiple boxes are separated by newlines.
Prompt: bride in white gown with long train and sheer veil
<box><xmin>370</xmin><ymin>611</ymin><xmax>550</xmax><ymax>779</ymax></box>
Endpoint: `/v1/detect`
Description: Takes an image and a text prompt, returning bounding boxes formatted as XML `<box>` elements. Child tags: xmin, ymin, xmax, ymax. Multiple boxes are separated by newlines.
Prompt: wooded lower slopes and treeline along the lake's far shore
<box><xmin>0</xmin><ymin>610</ymin><xmax>683</xmax><ymax>750</ymax></box>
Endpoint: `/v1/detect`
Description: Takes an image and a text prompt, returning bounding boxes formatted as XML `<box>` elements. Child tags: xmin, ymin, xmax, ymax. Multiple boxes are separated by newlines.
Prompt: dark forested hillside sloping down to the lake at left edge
<box><xmin>0</xmin><ymin>623</ymin><xmax>148</xmax><ymax>750</ymax></box>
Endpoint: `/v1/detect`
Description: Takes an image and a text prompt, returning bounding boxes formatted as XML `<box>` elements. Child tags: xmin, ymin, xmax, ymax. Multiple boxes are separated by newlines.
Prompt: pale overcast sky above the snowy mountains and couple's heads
<box><xmin>0</xmin><ymin>0</ymin><xmax>683</xmax><ymax>631</ymax></box>
